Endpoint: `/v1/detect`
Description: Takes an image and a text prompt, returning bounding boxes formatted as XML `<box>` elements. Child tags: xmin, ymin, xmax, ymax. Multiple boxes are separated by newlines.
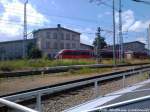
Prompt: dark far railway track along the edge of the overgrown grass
<box><xmin>0</xmin><ymin>63</ymin><xmax>149</xmax><ymax>78</ymax></box>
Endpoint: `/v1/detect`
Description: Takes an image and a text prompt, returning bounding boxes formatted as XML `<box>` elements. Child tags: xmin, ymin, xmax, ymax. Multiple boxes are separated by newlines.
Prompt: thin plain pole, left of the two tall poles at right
<box><xmin>112</xmin><ymin>0</ymin><xmax>116</xmax><ymax>66</ymax></box>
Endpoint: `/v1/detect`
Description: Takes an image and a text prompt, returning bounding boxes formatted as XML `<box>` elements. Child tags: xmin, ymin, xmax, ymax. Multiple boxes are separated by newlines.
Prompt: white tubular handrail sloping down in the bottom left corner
<box><xmin>0</xmin><ymin>98</ymin><xmax>38</xmax><ymax>112</ymax></box>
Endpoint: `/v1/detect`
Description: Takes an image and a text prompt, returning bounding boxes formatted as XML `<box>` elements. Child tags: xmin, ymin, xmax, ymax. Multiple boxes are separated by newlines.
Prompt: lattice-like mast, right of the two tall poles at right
<box><xmin>119</xmin><ymin>0</ymin><xmax>124</xmax><ymax>62</ymax></box>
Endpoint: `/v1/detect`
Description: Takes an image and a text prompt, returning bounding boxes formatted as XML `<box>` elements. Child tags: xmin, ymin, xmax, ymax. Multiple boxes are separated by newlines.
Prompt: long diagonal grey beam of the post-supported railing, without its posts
<box><xmin>3</xmin><ymin>68</ymin><xmax>150</xmax><ymax>101</ymax></box>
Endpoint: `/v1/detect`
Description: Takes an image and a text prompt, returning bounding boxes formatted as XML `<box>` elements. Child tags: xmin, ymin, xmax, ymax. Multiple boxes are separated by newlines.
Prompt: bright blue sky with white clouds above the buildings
<box><xmin>0</xmin><ymin>0</ymin><xmax>150</xmax><ymax>44</ymax></box>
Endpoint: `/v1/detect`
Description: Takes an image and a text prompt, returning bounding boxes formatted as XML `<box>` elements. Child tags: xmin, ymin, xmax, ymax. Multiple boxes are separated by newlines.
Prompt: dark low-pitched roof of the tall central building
<box><xmin>33</xmin><ymin>27</ymin><xmax>81</xmax><ymax>35</ymax></box>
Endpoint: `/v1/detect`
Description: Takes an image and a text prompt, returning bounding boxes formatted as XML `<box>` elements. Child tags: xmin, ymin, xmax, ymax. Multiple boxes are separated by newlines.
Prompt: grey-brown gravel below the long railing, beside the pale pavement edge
<box><xmin>39</xmin><ymin>71</ymin><xmax>147</xmax><ymax>112</ymax></box>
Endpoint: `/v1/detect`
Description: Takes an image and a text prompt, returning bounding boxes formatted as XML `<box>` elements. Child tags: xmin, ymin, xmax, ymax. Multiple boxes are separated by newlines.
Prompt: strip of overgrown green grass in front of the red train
<box><xmin>0</xmin><ymin>58</ymin><xmax>150</xmax><ymax>71</ymax></box>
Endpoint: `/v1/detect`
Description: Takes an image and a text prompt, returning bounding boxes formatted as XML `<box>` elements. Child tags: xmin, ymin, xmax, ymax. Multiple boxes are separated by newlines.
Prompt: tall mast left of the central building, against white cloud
<box><xmin>23</xmin><ymin>0</ymin><xmax>28</xmax><ymax>58</ymax></box>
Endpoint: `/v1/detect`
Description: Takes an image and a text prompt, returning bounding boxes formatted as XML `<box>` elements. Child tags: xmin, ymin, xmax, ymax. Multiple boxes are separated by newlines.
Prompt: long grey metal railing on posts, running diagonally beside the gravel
<box><xmin>3</xmin><ymin>68</ymin><xmax>150</xmax><ymax>112</ymax></box>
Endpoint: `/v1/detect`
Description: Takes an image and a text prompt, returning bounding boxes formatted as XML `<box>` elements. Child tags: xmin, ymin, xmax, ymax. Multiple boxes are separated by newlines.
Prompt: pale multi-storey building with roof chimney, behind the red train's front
<box><xmin>33</xmin><ymin>24</ymin><xmax>80</xmax><ymax>58</ymax></box>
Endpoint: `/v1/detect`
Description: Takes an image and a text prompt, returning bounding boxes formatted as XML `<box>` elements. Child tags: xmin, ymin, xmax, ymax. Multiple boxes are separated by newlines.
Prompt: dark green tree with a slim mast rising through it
<box><xmin>93</xmin><ymin>27</ymin><xmax>107</xmax><ymax>63</ymax></box>
